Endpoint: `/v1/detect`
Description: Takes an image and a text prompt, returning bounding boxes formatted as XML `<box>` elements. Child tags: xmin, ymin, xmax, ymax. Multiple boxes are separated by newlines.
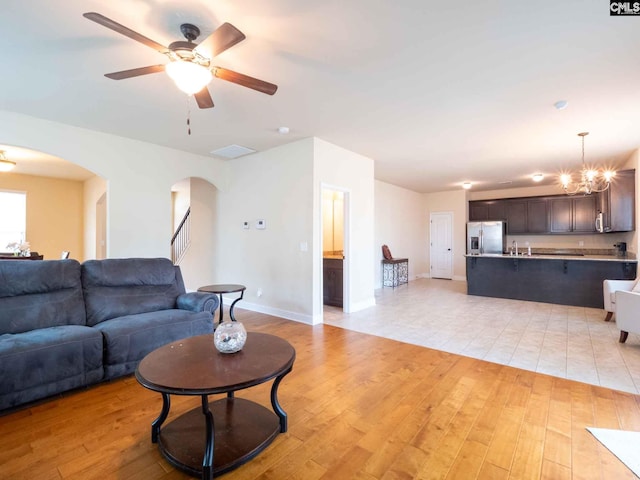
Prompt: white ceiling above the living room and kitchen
<box><xmin>0</xmin><ymin>0</ymin><xmax>640</xmax><ymax>192</ymax></box>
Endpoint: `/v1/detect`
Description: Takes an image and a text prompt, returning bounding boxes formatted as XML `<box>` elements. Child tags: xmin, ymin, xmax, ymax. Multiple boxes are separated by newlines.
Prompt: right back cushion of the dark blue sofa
<box><xmin>82</xmin><ymin>258</ymin><xmax>185</xmax><ymax>326</ymax></box>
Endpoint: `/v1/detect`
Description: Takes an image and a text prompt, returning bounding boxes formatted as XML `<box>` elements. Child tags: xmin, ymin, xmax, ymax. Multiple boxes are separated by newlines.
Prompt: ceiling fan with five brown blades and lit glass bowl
<box><xmin>83</xmin><ymin>12</ymin><xmax>278</xmax><ymax>108</ymax></box>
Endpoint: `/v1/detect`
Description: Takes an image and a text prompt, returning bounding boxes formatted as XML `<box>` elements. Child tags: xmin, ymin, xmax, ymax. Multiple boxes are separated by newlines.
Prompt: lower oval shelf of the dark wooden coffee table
<box><xmin>158</xmin><ymin>398</ymin><xmax>280</xmax><ymax>477</ymax></box>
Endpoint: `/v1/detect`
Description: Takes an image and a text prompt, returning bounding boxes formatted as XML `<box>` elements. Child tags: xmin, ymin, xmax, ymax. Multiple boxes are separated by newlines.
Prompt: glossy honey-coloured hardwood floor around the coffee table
<box><xmin>0</xmin><ymin>310</ymin><xmax>640</xmax><ymax>480</ymax></box>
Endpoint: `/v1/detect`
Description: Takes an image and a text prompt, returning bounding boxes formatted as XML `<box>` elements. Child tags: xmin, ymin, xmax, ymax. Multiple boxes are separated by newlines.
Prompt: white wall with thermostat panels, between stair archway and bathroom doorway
<box><xmin>214</xmin><ymin>139</ymin><xmax>313</xmax><ymax>323</ymax></box>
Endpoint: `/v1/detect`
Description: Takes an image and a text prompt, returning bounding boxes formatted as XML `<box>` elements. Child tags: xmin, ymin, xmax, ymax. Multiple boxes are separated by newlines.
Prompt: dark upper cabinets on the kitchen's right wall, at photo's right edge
<box><xmin>596</xmin><ymin>170</ymin><xmax>636</xmax><ymax>232</ymax></box>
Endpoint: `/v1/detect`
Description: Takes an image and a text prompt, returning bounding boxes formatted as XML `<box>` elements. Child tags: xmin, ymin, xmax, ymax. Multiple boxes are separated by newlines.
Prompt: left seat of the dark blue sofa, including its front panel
<box><xmin>0</xmin><ymin>325</ymin><xmax>103</xmax><ymax>410</ymax></box>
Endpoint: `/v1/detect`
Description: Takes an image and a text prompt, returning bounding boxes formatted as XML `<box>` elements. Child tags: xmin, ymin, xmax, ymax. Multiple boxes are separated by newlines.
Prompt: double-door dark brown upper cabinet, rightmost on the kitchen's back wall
<box><xmin>549</xmin><ymin>195</ymin><xmax>597</xmax><ymax>233</ymax></box>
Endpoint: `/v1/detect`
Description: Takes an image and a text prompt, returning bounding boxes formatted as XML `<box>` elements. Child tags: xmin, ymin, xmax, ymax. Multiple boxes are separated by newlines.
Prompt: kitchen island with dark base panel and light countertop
<box><xmin>465</xmin><ymin>253</ymin><xmax>638</xmax><ymax>308</ymax></box>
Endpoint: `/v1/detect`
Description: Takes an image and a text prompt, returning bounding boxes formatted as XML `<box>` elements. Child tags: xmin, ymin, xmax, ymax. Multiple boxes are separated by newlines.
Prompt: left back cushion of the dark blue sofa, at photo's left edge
<box><xmin>0</xmin><ymin>260</ymin><xmax>86</xmax><ymax>335</ymax></box>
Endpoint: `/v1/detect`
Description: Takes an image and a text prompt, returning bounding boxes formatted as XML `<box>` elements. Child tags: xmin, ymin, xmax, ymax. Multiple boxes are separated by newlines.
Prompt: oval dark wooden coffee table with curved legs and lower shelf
<box><xmin>136</xmin><ymin>332</ymin><xmax>296</xmax><ymax>479</ymax></box>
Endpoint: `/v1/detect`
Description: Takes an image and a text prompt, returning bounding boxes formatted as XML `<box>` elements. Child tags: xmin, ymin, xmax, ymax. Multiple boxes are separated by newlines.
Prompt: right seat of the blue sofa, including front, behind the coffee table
<box><xmin>93</xmin><ymin>309</ymin><xmax>213</xmax><ymax>378</ymax></box>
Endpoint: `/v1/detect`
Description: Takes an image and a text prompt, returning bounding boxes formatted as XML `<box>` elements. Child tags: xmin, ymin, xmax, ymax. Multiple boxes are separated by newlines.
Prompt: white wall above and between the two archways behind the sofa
<box><xmin>0</xmin><ymin>111</ymin><xmax>225</xmax><ymax>268</ymax></box>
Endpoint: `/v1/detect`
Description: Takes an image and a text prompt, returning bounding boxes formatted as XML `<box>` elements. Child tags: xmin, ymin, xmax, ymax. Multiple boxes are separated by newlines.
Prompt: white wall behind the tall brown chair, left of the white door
<box><xmin>373</xmin><ymin>180</ymin><xmax>429</xmax><ymax>288</ymax></box>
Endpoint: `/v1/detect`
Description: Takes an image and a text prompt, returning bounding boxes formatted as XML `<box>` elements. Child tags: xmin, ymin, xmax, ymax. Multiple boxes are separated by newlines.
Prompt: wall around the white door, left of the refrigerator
<box><xmin>425</xmin><ymin>190</ymin><xmax>468</xmax><ymax>280</ymax></box>
